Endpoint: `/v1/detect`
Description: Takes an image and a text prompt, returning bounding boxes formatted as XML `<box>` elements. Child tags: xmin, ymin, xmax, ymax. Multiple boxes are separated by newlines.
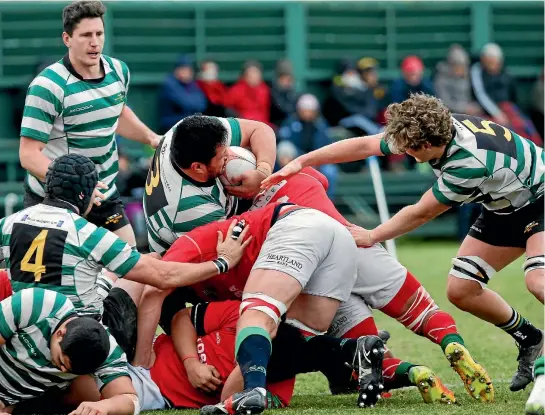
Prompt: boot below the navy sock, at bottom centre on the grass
<box><xmin>199</xmin><ymin>388</ymin><xmax>267</xmax><ymax>415</ymax></box>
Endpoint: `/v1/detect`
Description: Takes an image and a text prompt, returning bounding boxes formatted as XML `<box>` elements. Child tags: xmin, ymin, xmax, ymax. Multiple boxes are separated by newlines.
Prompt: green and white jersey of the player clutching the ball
<box><xmin>144</xmin><ymin>118</ymin><xmax>242</xmax><ymax>254</ymax></box>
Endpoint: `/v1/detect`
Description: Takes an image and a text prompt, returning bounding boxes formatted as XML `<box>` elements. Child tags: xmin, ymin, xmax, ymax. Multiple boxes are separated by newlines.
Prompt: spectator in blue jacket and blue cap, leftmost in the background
<box><xmin>159</xmin><ymin>56</ymin><xmax>206</xmax><ymax>133</ymax></box>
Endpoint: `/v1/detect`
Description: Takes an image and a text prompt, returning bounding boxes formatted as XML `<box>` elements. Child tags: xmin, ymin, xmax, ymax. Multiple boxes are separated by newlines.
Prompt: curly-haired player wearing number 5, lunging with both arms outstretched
<box><xmin>263</xmin><ymin>94</ymin><xmax>545</xmax><ymax>391</ymax></box>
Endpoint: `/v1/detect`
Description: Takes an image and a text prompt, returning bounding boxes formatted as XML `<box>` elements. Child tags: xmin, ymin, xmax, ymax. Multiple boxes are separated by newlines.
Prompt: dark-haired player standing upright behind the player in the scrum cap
<box><xmin>19</xmin><ymin>0</ymin><xmax>160</xmax><ymax>246</ymax></box>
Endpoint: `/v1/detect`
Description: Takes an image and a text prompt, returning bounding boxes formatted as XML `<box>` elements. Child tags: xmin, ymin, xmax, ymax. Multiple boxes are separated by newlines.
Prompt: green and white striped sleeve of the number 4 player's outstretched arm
<box><xmin>71</xmin><ymin>215</ymin><xmax>140</xmax><ymax>277</ymax></box>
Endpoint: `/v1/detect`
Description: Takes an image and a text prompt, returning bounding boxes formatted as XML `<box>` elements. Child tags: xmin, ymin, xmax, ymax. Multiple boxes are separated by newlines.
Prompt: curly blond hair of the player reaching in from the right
<box><xmin>384</xmin><ymin>94</ymin><xmax>452</xmax><ymax>154</ymax></box>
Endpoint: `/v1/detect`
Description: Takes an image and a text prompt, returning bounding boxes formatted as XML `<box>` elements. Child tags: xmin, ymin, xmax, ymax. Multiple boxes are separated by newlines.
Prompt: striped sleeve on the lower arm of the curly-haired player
<box><xmin>432</xmin><ymin>164</ymin><xmax>487</xmax><ymax>206</ymax></box>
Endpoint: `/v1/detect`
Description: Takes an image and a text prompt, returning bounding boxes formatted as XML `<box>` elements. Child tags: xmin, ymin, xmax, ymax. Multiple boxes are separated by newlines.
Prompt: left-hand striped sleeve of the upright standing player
<box><xmin>20</xmin><ymin>68</ymin><xmax>66</xmax><ymax>143</ymax></box>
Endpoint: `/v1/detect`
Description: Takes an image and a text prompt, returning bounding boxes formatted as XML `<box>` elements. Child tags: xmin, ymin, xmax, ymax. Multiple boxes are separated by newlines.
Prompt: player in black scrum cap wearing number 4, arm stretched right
<box><xmin>0</xmin><ymin>154</ymin><xmax>250</xmax><ymax>357</ymax></box>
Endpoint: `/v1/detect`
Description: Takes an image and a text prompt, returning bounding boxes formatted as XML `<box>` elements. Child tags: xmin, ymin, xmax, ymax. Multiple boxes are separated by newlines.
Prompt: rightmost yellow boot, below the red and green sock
<box><xmin>445</xmin><ymin>343</ymin><xmax>494</xmax><ymax>402</ymax></box>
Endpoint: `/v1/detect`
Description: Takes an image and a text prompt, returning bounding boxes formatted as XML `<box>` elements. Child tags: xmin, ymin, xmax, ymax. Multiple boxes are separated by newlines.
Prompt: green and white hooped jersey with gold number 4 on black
<box><xmin>0</xmin><ymin>201</ymin><xmax>140</xmax><ymax>314</ymax></box>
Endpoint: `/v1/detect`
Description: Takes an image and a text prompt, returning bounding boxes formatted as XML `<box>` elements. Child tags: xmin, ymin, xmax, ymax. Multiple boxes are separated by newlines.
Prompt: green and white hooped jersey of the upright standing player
<box><xmin>21</xmin><ymin>55</ymin><xmax>130</xmax><ymax>201</ymax></box>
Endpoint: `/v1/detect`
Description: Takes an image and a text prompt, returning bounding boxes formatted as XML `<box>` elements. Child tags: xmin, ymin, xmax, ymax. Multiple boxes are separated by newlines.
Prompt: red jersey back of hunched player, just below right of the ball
<box><xmin>250</xmin><ymin>167</ymin><xmax>348</xmax><ymax>225</ymax></box>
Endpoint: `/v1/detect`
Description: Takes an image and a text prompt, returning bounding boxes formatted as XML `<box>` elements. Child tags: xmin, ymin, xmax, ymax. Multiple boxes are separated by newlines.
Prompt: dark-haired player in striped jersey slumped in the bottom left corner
<box><xmin>0</xmin><ymin>288</ymin><xmax>139</xmax><ymax>415</ymax></box>
